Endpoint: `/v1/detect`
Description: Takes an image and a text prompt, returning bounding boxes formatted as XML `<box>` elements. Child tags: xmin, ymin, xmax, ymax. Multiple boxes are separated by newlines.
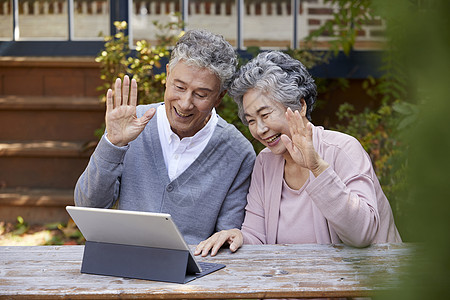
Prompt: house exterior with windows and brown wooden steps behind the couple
<box><xmin>0</xmin><ymin>0</ymin><xmax>385</xmax><ymax>223</ymax></box>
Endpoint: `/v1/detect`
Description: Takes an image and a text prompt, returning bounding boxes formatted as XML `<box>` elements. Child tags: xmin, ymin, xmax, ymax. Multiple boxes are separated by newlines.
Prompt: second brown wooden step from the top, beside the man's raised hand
<box><xmin>0</xmin><ymin>96</ymin><xmax>105</xmax><ymax>141</ymax></box>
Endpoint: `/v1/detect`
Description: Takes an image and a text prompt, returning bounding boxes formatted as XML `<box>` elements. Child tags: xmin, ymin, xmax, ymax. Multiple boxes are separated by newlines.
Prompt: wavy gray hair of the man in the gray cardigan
<box><xmin>169</xmin><ymin>30</ymin><xmax>237</xmax><ymax>92</ymax></box>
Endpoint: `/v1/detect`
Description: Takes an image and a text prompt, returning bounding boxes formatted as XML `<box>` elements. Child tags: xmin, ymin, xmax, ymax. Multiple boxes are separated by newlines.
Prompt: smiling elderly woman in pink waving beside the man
<box><xmin>195</xmin><ymin>51</ymin><xmax>401</xmax><ymax>256</ymax></box>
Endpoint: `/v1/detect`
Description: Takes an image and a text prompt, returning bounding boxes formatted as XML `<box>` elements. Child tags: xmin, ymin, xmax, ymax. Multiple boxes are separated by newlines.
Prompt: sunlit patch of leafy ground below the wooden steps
<box><xmin>0</xmin><ymin>217</ymin><xmax>85</xmax><ymax>246</ymax></box>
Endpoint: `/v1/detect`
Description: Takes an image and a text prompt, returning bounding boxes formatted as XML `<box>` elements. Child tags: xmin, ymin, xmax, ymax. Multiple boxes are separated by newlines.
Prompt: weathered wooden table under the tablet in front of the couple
<box><xmin>0</xmin><ymin>244</ymin><xmax>413</xmax><ymax>299</ymax></box>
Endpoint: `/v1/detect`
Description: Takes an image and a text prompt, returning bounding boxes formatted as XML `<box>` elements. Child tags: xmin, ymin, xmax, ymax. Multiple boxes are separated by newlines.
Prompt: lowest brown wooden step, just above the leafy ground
<box><xmin>0</xmin><ymin>189</ymin><xmax>74</xmax><ymax>224</ymax></box>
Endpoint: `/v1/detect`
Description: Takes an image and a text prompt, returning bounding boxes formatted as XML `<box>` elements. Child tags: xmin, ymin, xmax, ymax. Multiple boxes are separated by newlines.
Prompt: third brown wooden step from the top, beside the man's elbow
<box><xmin>0</xmin><ymin>141</ymin><xmax>96</xmax><ymax>189</ymax></box>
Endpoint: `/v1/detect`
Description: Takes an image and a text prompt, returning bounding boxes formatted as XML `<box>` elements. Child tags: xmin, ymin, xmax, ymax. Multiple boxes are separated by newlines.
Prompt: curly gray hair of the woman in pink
<box><xmin>228</xmin><ymin>51</ymin><xmax>317</xmax><ymax>125</ymax></box>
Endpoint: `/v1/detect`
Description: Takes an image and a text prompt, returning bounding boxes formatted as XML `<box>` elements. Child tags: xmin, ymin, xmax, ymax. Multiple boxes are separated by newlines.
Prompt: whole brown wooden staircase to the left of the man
<box><xmin>0</xmin><ymin>57</ymin><xmax>105</xmax><ymax>224</ymax></box>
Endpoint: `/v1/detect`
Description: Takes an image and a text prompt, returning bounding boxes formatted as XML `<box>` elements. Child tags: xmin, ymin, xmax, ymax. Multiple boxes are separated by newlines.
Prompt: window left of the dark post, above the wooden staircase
<box><xmin>0</xmin><ymin>0</ymin><xmax>110</xmax><ymax>41</ymax></box>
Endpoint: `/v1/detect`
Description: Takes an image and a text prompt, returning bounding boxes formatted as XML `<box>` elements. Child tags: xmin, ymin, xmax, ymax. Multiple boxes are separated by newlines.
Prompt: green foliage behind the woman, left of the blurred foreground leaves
<box><xmin>293</xmin><ymin>0</ymin><xmax>418</xmax><ymax>240</ymax></box>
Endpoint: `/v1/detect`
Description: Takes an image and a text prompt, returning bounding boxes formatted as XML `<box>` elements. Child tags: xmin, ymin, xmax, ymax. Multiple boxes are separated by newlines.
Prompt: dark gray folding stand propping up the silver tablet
<box><xmin>81</xmin><ymin>241</ymin><xmax>210</xmax><ymax>283</ymax></box>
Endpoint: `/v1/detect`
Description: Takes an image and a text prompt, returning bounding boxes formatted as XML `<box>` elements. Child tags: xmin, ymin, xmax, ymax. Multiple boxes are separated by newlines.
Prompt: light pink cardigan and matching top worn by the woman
<box><xmin>242</xmin><ymin>126</ymin><xmax>401</xmax><ymax>247</ymax></box>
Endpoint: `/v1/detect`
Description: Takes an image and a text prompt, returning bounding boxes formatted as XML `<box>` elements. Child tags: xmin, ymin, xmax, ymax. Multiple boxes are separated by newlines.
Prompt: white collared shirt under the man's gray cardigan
<box><xmin>156</xmin><ymin>104</ymin><xmax>218</xmax><ymax>181</ymax></box>
